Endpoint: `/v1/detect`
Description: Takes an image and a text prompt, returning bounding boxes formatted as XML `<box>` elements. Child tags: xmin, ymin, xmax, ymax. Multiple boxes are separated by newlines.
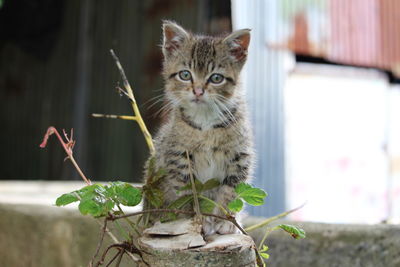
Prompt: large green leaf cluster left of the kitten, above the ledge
<box><xmin>56</xmin><ymin>182</ymin><xmax>142</xmax><ymax>217</ymax></box>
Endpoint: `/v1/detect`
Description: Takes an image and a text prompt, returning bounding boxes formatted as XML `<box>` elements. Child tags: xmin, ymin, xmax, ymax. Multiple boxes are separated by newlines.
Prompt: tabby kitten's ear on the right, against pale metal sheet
<box><xmin>223</xmin><ymin>29</ymin><xmax>250</xmax><ymax>61</ymax></box>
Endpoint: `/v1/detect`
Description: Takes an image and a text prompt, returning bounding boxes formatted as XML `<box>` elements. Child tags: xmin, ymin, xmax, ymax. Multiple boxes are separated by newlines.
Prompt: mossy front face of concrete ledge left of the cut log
<box><xmin>0</xmin><ymin>203</ymin><xmax>132</xmax><ymax>267</ymax></box>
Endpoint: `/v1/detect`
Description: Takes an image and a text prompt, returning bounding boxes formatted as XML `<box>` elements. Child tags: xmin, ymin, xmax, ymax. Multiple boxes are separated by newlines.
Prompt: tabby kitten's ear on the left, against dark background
<box><xmin>162</xmin><ymin>20</ymin><xmax>190</xmax><ymax>56</ymax></box>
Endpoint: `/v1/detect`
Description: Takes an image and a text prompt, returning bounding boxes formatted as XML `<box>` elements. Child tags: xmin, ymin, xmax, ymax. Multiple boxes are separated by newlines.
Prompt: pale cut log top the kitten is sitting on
<box><xmin>139</xmin><ymin>219</ymin><xmax>256</xmax><ymax>267</ymax></box>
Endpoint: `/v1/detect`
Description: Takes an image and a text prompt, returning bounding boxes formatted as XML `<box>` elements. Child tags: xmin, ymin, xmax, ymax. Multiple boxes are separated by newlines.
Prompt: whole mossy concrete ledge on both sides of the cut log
<box><xmin>0</xmin><ymin>203</ymin><xmax>400</xmax><ymax>267</ymax></box>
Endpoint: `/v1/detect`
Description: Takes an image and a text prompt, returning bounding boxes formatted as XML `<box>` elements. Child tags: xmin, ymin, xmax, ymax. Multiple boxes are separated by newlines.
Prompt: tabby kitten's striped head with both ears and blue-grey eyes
<box><xmin>162</xmin><ymin>21</ymin><xmax>250</xmax><ymax>111</ymax></box>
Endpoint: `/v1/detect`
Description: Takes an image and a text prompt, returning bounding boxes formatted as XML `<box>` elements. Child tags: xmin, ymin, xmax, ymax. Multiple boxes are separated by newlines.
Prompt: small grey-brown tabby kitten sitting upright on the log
<box><xmin>145</xmin><ymin>21</ymin><xmax>254</xmax><ymax>235</ymax></box>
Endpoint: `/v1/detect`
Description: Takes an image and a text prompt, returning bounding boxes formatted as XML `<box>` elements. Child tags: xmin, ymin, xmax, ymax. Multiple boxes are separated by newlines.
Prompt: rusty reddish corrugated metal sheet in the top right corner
<box><xmin>276</xmin><ymin>0</ymin><xmax>400</xmax><ymax>77</ymax></box>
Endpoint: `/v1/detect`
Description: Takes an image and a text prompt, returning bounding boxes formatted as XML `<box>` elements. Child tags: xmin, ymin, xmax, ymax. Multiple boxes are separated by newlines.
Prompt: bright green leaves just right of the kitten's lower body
<box><xmin>228</xmin><ymin>183</ymin><xmax>267</xmax><ymax>212</ymax></box>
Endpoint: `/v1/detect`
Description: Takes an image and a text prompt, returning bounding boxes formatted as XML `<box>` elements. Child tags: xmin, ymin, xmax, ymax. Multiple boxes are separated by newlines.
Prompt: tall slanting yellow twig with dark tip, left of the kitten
<box><xmin>110</xmin><ymin>49</ymin><xmax>155</xmax><ymax>155</ymax></box>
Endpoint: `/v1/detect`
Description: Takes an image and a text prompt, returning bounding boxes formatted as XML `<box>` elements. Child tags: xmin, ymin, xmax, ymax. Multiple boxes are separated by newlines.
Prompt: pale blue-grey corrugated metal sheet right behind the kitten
<box><xmin>232</xmin><ymin>0</ymin><xmax>285</xmax><ymax>216</ymax></box>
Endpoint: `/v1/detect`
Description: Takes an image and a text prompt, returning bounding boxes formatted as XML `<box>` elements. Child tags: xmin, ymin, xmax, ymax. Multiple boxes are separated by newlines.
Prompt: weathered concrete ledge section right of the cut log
<box><xmin>246</xmin><ymin>218</ymin><xmax>400</xmax><ymax>267</ymax></box>
